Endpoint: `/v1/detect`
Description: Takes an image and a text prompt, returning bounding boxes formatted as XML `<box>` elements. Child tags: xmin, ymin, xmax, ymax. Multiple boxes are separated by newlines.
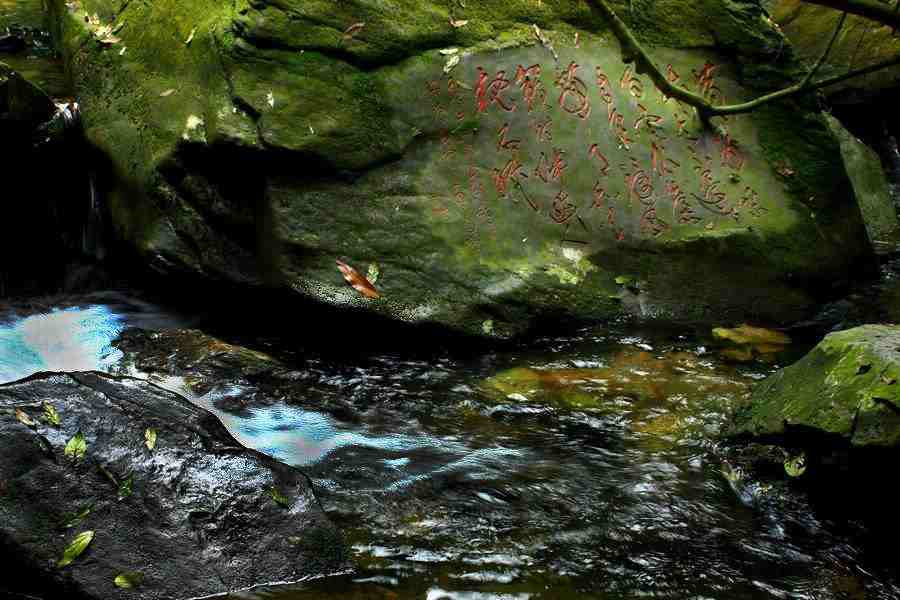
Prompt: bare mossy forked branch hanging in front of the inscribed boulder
<box><xmin>589</xmin><ymin>0</ymin><xmax>900</xmax><ymax>125</ymax></box>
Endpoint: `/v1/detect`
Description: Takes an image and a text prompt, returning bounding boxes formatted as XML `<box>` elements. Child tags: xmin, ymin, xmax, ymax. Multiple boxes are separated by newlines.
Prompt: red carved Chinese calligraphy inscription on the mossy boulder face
<box><xmin>424</xmin><ymin>47</ymin><xmax>770</xmax><ymax>251</ymax></box>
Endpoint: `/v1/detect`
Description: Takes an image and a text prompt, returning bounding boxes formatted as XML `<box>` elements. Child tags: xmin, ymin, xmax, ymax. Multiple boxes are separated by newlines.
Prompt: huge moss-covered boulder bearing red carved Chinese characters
<box><xmin>50</xmin><ymin>0</ymin><xmax>870</xmax><ymax>337</ymax></box>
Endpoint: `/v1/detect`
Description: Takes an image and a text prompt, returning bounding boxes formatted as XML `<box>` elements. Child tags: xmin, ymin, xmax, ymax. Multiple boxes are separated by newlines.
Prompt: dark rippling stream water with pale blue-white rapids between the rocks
<box><xmin>0</xmin><ymin>295</ymin><xmax>900</xmax><ymax>600</ymax></box>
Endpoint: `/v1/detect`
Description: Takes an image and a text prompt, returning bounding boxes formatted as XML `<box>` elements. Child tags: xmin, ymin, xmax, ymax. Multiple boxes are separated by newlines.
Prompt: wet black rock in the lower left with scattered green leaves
<box><xmin>0</xmin><ymin>372</ymin><xmax>348</xmax><ymax>599</ymax></box>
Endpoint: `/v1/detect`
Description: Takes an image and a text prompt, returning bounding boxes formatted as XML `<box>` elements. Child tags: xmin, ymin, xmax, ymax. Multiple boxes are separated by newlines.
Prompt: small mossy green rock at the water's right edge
<box><xmin>732</xmin><ymin>325</ymin><xmax>900</xmax><ymax>449</ymax></box>
